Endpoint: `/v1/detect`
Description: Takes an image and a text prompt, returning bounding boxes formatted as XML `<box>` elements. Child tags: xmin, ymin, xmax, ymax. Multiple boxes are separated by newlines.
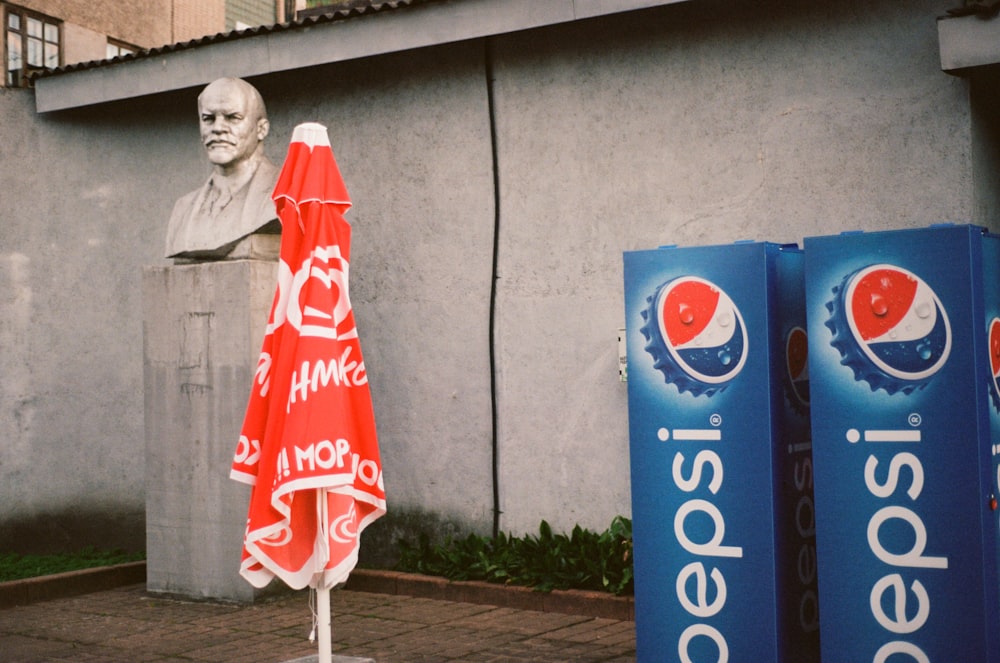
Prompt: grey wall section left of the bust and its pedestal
<box><xmin>0</xmin><ymin>89</ymin><xmax>203</xmax><ymax>548</ymax></box>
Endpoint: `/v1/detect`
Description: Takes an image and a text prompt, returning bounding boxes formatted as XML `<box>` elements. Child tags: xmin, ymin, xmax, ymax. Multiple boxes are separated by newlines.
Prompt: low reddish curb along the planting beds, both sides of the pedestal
<box><xmin>0</xmin><ymin>562</ymin><xmax>635</xmax><ymax>621</ymax></box>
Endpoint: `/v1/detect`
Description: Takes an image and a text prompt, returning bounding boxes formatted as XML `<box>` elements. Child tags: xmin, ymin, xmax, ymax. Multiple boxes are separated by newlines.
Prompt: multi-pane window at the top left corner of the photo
<box><xmin>4</xmin><ymin>5</ymin><xmax>62</xmax><ymax>87</ymax></box>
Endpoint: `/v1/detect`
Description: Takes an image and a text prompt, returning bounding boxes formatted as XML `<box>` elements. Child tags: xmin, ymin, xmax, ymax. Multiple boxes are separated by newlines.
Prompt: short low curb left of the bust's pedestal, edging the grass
<box><xmin>0</xmin><ymin>562</ymin><xmax>146</xmax><ymax>608</ymax></box>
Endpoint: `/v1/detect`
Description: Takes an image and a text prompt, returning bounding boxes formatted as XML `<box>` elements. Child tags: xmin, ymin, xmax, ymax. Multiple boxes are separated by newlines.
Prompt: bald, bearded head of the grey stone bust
<box><xmin>198</xmin><ymin>80</ymin><xmax>267</xmax><ymax>168</ymax></box>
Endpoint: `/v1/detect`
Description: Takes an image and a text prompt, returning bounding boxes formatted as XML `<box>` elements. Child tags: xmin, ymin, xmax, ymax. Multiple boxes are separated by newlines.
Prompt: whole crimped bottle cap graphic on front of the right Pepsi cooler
<box><xmin>826</xmin><ymin>264</ymin><xmax>951</xmax><ymax>394</ymax></box>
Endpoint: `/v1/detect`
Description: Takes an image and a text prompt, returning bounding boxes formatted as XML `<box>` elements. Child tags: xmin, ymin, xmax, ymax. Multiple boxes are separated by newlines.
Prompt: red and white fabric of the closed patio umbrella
<box><xmin>230</xmin><ymin>123</ymin><xmax>385</xmax><ymax>589</ymax></box>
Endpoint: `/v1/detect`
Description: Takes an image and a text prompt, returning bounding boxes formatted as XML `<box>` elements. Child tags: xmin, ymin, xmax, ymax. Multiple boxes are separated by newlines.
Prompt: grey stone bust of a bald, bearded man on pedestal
<box><xmin>166</xmin><ymin>78</ymin><xmax>281</xmax><ymax>261</ymax></box>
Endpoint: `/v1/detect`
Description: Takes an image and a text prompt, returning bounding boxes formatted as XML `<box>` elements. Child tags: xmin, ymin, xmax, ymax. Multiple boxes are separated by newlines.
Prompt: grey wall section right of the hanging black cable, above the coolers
<box><xmin>496</xmin><ymin>0</ymin><xmax>976</xmax><ymax>530</ymax></box>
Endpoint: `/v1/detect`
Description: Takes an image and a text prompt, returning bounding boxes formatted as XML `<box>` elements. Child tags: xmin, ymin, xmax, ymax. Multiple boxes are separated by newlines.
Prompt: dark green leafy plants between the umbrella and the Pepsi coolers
<box><xmin>396</xmin><ymin>516</ymin><xmax>633</xmax><ymax>594</ymax></box>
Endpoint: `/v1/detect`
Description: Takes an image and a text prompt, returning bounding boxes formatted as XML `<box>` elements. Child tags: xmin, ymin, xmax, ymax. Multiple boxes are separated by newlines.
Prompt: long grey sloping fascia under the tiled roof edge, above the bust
<box><xmin>35</xmin><ymin>0</ymin><xmax>685</xmax><ymax>113</ymax></box>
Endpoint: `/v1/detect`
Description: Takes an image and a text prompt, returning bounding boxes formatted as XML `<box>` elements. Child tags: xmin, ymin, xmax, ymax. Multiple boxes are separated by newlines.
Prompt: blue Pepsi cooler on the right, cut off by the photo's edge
<box><xmin>805</xmin><ymin>225</ymin><xmax>1000</xmax><ymax>663</ymax></box>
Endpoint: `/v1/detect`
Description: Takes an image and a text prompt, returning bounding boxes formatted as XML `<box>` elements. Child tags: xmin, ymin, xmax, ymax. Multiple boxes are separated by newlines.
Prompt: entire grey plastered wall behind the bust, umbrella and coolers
<box><xmin>0</xmin><ymin>0</ymin><xmax>984</xmax><ymax>554</ymax></box>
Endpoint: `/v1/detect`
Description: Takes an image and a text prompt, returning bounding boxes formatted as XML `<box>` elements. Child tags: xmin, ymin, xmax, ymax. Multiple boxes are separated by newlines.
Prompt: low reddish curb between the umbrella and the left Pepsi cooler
<box><xmin>344</xmin><ymin>569</ymin><xmax>635</xmax><ymax>621</ymax></box>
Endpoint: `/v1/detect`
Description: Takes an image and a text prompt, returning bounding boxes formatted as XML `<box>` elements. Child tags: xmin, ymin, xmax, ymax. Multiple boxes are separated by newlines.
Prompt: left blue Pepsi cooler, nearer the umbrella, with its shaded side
<box><xmin>624</xmin><ymin>242</ymin><xmax>819</xmax><ymax>663</ymax></box>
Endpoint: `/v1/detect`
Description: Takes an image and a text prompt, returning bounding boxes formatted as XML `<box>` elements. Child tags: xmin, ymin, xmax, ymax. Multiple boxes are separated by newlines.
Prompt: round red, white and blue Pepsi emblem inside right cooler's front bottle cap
<box><xmin>844</xmin><ymin>264</ymin><xmax>951</xmax><ymax>381</ymax></box>
